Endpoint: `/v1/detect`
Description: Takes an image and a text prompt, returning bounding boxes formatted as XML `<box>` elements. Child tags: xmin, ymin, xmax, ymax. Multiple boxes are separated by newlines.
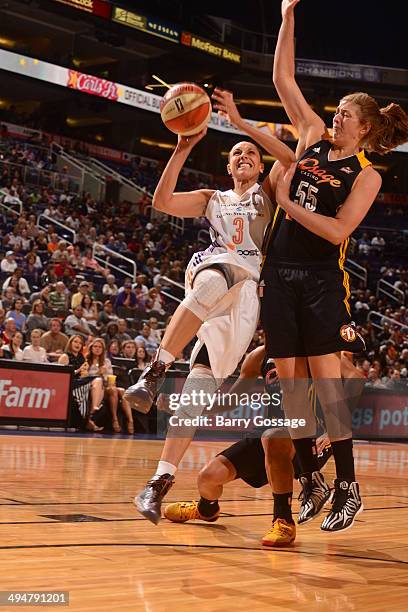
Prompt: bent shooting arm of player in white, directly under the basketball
<box><xmin>153</xmin><ymin>128</ymin><xmax>214</xmax><ymax>217</ymax></box>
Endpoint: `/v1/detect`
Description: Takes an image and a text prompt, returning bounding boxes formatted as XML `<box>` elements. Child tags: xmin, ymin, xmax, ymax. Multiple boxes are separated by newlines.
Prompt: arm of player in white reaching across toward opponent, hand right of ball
<box><xmin>212</xmin><ymin>87</ymin><xmax>295</xmax><ymax>166</ymax></box>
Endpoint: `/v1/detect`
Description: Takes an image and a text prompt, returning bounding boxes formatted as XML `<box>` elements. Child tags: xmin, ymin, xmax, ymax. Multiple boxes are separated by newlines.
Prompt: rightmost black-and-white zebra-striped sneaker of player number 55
<box><xmin>321</xmin><ymin>478</ymin><xmax>364</xmax><ymax>532</ymax></box>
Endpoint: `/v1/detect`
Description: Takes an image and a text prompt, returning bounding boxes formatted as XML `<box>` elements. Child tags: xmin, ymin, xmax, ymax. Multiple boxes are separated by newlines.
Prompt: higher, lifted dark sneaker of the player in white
<box><xmin>123</xmin><ymin>361</ymin><xmax>166</xmax><ymax>414</ymax></box>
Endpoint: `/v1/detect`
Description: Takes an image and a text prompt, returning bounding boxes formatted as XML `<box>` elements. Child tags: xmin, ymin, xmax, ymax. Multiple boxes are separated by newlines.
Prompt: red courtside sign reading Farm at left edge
<box><xmin>0</xmin><ymin>364</ymin><xmax>71</xmax><ymax>421</ymax></box>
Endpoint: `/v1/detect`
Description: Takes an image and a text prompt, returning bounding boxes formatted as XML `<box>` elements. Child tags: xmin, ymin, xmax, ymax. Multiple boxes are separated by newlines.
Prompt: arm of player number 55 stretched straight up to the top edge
<box><xmin>273</xmin><ymin>0</ymin><xmax>327</xmax><ymax>148</ymax></box>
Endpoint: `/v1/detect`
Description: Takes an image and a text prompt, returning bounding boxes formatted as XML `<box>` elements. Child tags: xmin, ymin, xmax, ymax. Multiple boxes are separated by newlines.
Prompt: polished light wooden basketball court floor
<box><xmin>0</xmin><ymin>433</ymin><xmax>408</xmax><ymax>612</ymax></box>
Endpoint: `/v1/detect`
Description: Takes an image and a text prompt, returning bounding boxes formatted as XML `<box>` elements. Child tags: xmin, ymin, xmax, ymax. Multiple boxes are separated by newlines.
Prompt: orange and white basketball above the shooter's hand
<box><xmin>160</xmin><ymin>83</ymin><xmax>211</xmax><ymax>136</ymax></box>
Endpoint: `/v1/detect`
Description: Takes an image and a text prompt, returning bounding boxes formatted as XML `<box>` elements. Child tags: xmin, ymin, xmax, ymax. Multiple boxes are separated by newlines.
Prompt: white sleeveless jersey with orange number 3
<box><xmin>186</xmin><ymin>183</ymin><xmax>272</xmax><ymax>286</ymax></box>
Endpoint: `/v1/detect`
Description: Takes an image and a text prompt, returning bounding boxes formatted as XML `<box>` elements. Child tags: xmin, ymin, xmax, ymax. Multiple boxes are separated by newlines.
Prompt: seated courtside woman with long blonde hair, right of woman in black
<box><xmin>87</xmin><ymin>338</ymin><xmax>134</xmax><ymax>433</ymax></box>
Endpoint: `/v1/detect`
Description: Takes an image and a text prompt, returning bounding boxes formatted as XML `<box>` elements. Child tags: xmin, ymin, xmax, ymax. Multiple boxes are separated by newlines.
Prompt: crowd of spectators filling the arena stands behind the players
<box><xmin>0</xmin><ymin>130</ymin><xmax>408</xmax><ymax>396</ymax></box>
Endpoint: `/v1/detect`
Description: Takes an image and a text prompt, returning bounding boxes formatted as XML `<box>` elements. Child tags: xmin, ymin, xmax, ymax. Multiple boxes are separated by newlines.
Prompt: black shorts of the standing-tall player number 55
<box><xmin>261</xmin><ymin>265</ymin><xmax>365</xmax><ymax>358</ymax></box>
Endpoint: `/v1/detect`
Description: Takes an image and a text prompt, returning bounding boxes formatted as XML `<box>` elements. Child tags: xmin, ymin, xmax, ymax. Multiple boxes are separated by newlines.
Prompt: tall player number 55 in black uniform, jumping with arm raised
<box><xmin>261</xmin><ymin>0</ymin><xmax>408</xmax><ymax>532</ymax></box>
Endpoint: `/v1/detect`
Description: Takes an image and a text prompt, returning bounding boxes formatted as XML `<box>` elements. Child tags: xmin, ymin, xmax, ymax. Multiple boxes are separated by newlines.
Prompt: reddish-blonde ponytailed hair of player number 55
<box><xmin>341</xmin><ymin>92</ymin><xmax>408</xmax><ymax>155</ymax></box>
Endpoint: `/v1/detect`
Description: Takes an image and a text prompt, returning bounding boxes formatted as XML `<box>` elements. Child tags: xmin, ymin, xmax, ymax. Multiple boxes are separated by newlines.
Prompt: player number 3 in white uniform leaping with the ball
<box><xmin>125</xmin><ymin>90</ymin><xmax>295</xmax><ymax>524</ymax></box>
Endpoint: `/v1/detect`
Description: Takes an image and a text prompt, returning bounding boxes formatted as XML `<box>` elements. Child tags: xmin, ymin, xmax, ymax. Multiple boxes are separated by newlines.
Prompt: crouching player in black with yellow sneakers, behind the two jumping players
<box><xmin>164</xmin><ymin>346</ymin><xmax>332</xmax><ymax>547</ymax></box>
